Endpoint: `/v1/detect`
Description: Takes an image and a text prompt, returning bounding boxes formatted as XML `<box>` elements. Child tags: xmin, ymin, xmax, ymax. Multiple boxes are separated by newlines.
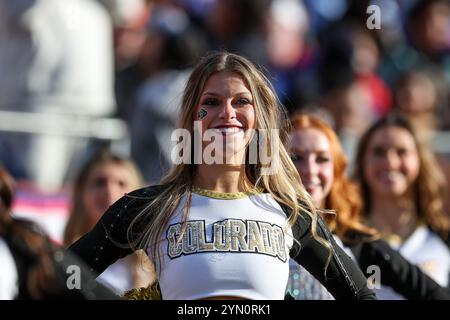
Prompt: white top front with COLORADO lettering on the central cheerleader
<box><xmin>149</xmin><ymin>189</ymin><xmax>293</xmax><ymax>300</ymax></box>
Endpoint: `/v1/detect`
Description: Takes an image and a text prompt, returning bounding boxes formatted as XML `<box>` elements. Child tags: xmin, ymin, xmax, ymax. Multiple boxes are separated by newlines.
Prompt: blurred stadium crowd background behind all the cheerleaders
<box><xmin>0</xmin><ymin>0</ymin><xmax>450</xmax><ymax>280</ymax></box>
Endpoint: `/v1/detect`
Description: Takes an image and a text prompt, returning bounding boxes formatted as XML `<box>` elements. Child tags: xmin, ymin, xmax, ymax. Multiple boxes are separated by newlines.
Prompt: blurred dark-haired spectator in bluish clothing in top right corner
<box><xmin>374</xmin><ymin>0</ymin><xmax>450</xmax><ymax>90</ymax></box>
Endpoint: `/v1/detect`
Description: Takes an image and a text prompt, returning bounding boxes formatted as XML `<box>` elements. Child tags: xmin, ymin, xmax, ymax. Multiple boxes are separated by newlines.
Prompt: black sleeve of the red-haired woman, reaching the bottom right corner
<box><xmin>349</xmin><ymin>240</ymin><xmax>450</xmax><ymax>300</ymax></box>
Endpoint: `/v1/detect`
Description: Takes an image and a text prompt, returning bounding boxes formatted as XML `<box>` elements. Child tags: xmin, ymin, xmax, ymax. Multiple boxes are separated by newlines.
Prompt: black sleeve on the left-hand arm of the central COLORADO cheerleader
<box><xmin>69</xmin><ymin>187</ymin><xmax>161</xmax><ymax>273</ymax></box>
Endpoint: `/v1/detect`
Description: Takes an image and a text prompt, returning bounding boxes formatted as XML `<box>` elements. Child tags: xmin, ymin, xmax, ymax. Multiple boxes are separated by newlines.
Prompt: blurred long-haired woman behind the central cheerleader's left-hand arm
<box><xmin>64</xmin><ymin>150</ymin><xmax>154</xmax><ymax>294</ymax></box>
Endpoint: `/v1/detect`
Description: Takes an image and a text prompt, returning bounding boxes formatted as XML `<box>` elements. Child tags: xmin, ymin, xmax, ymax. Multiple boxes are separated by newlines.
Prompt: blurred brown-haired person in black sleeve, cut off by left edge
<box><xmin>0</xmin><ymin>168</ymin><xmax>117</xmax><ymax>300</ymax></box>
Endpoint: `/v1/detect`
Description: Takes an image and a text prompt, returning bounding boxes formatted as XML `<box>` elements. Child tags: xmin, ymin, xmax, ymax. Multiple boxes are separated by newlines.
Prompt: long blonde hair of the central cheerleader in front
<box><xmin>128</xmin><ymin>52</ymin><xmax>331</xmax><ymax>270</ymax></box>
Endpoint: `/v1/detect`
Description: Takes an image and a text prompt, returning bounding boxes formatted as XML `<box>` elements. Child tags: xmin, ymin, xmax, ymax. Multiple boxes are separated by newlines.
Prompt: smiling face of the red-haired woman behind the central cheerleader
<box><xmin>289</xmin><ymin>128</ymin><xmax>334</xmax><ymax>208</ymax></box>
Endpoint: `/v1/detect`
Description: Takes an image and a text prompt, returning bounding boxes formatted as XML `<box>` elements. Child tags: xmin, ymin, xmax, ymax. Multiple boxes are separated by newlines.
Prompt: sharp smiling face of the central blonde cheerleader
<box><xmin>195</xmin><ymin>71</ymin><xmax>256</xmax><ymax>164</ymax></box>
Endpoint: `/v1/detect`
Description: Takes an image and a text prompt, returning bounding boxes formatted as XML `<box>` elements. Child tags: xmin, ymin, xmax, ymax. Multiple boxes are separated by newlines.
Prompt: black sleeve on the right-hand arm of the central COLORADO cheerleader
<box><xmin>291</xmin><ymin>212</ymin><xmax>376</xmax><ymax>300</ymax></box>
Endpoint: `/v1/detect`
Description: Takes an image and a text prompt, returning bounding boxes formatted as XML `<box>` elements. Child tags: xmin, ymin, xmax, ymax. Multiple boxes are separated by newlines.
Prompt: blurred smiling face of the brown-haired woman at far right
<box><xmin>364</xmin><ymin>126</ymin><xmax>420</xmax><ymax>197</ymax></box>
